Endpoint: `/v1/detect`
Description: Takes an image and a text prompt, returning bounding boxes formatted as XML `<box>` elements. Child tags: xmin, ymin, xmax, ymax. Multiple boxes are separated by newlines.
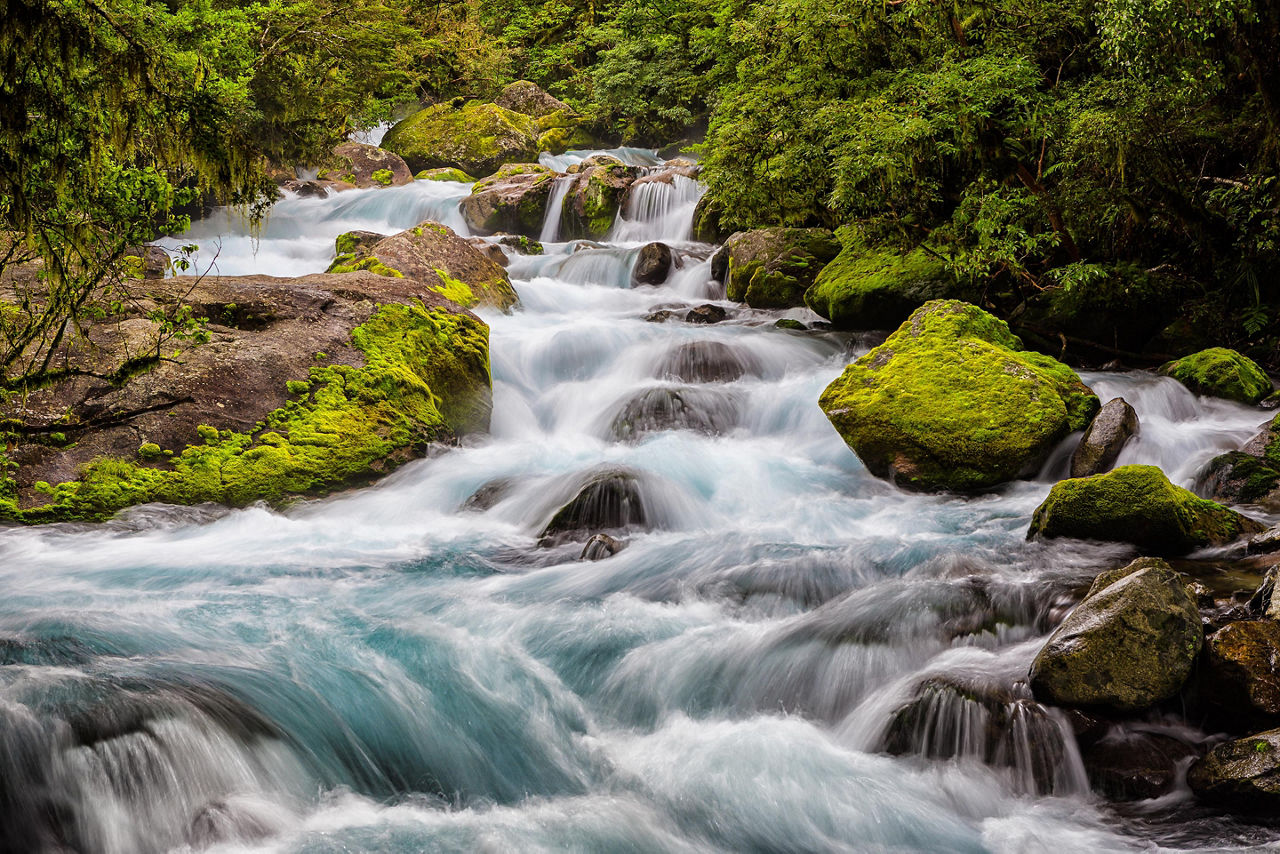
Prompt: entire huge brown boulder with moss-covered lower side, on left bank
<box><xmin>0</xmin><ymin>271</ymin><xmax>490</xmax><ymax>522</ymax></box>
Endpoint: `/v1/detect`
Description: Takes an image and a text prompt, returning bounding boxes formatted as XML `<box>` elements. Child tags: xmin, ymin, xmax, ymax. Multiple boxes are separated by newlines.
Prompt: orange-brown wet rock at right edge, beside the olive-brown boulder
<box><xmin>1201</xmin><ymin>620</ymin><xmax>1280</xmax><ymax>732</ymax></box>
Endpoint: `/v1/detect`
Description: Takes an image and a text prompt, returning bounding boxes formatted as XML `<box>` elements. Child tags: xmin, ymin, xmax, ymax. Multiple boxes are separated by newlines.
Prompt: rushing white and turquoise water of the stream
<box><xmin>0</xmin><ymin>152</ymin><xmax>1268</xmax><ymax>854</ymax></box>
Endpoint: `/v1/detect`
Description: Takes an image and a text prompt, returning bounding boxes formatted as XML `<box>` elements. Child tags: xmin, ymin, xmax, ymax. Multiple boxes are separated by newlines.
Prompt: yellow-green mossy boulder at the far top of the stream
<box><xmin>383</xmin><ymin>102</ymin><xmax>540</xmax><ymax>175</ymax></box>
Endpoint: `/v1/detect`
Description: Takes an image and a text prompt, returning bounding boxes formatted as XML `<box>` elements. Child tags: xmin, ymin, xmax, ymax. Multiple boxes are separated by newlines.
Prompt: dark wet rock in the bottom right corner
<box><xmin>1187</xmin><ymin>730</ymin><xmax>1280</xmax><ymax>813</ymax></box>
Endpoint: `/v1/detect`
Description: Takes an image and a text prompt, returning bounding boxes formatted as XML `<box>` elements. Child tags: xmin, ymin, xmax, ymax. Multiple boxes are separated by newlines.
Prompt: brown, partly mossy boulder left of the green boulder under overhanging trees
<box><xmin>714</xmin><ymin>228</ymin><xmax>840</xmax><ymax>309</ymax></box>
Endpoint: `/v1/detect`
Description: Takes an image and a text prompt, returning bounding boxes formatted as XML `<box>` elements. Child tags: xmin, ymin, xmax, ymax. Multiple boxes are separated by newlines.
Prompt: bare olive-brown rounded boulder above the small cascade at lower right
<box><xmin>1030</xmin><ymin>558</ymin><xmax>1203</xmax><ymax>712</ymax></box>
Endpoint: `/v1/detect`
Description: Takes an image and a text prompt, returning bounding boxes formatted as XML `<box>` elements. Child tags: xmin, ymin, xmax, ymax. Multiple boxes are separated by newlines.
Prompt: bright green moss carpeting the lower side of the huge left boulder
<box><xmin>8</xmin><ymin>303</ymin><xmax>489</xmax><ymax>522</ymax></box>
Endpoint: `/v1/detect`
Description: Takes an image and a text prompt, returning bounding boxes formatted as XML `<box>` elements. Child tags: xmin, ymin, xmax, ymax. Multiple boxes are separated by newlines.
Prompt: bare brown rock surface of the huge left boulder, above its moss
<box><xmin>8</xmin><ymin>271</ymin><xmax>489</xmax><ymax>507</ymax></box>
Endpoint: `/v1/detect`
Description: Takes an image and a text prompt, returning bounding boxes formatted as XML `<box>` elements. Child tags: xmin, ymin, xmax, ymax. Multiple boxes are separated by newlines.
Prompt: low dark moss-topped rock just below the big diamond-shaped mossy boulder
<box><xmin>1027</xmin><ymin>466</ymin><xmax>1263</xmax><ymax>554</ymax></box>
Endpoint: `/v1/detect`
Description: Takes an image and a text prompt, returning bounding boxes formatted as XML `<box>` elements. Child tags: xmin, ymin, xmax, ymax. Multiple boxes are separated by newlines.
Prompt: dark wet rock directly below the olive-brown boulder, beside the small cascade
<box><xmin>1080</xmin><ymin>727</ymin><xmax>1201</xmax><ymax>800</ymax></box>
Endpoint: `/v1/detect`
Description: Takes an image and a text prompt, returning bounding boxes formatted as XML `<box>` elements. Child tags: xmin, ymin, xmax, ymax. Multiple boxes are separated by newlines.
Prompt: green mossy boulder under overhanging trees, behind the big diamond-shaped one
<box><xmin>804</xmin><ymin>240</ymin><xmax>974</xmax><ymax>329</ymax></box>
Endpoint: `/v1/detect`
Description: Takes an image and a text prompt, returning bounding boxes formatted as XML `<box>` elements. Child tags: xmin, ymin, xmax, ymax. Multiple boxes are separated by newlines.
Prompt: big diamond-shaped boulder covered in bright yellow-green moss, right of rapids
<box><xmin>819</xmin><ymin>301</ymin><xmax>1098</xmax><ymax>490</ymax></box>
